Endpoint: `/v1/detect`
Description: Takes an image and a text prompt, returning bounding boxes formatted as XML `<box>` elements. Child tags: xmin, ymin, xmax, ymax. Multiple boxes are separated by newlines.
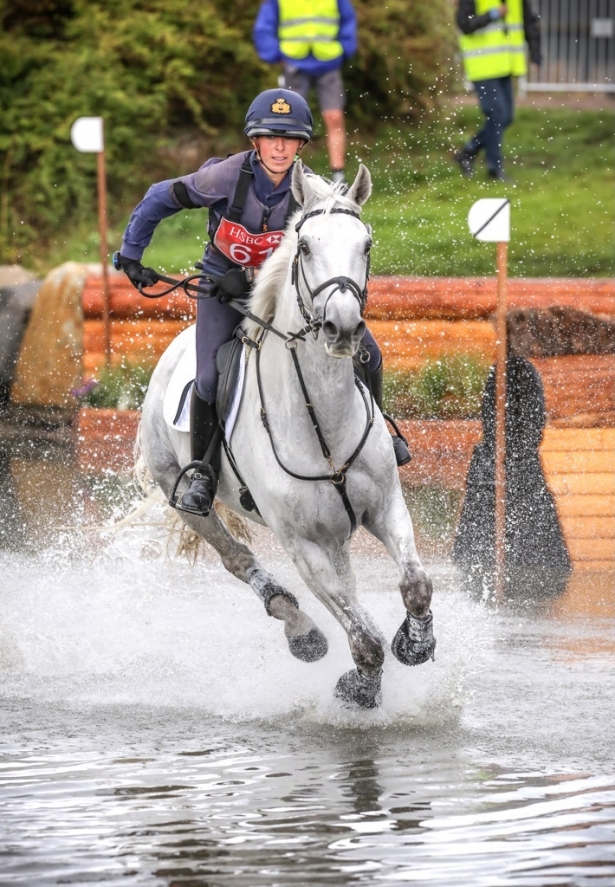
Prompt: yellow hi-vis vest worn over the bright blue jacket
<box><xmin>278</xmin><ymin>0</ymin><xmax>344</xmax><ymax>62</ymax></box>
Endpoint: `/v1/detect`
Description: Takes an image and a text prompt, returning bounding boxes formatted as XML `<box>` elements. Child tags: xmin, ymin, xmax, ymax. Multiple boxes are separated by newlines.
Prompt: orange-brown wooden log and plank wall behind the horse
<box><xmin>76</xmin><ymin>273</ymin><xmax>615</xmax><ymax>570</ymax></box>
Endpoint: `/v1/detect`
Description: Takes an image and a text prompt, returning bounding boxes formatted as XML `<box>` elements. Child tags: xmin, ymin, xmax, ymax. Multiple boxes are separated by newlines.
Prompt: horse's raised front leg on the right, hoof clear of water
<box><xmin>367</xmin><ymin>491</ymin><xmax>436</xmax><ymax>665</ymax></box>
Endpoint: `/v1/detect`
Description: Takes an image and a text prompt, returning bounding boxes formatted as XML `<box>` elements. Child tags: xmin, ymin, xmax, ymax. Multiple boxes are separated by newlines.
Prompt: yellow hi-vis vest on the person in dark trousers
<box><xmin>459</xmin><ymin>0</ymin><xmax>527</xmax><ymax>81</ymax></box>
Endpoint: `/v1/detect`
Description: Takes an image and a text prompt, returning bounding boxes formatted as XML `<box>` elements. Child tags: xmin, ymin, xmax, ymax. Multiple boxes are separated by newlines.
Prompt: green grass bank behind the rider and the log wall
<box><xmin>45</xmin><ymin>105</ymin><xmax>615</xmax><ymax>277</ymax></box>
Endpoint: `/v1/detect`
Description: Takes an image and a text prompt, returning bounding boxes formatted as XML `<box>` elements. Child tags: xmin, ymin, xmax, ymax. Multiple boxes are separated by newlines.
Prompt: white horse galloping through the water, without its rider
<box><xmin>140</xmin><ymin>163</ymin><xmax>435</xmax><ymax>708</ymax></box>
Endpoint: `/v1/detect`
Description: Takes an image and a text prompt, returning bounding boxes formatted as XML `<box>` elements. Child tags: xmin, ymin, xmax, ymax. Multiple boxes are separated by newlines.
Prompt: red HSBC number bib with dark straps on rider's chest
<box><xmin>209</xmin><ymin>158</ymin><xmax>298</xmax><ymax>268</ymax></box>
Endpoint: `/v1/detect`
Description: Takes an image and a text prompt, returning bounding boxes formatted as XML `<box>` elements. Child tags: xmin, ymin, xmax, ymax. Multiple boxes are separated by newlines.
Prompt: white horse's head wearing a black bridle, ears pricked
<box><xmin>292</xmin><ymin>162</ymin><xmax>372</xmax><ymax>357</ymax></box>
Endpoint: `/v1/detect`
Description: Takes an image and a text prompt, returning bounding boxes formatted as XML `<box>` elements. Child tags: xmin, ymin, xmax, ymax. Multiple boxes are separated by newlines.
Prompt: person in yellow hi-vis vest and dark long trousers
<box><xmin>455</xmin><ymin>0</ymin><xmax>541</xmax><ymax>181</ymax></box>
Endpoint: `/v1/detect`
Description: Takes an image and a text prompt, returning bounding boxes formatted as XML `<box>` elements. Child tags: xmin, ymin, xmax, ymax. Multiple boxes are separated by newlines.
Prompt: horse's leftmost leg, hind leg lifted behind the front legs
<box><xmin>173</xmin><ymin>510</ymin><xmax>328</xmax><ymax>662</ymax></box>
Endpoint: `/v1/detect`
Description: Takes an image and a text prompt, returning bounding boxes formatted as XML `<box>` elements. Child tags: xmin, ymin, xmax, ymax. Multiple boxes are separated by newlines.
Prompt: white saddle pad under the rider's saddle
<box><xmin>162</xmin><ymin>326</ymin><xmax>245</xmax><ymax>441</ymax></box>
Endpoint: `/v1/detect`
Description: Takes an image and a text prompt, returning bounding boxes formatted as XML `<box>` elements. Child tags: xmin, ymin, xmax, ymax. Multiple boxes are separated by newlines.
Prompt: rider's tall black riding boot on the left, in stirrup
<box><xmin>178</xmin><ymin>387</ymin><xmax>220</xmax><ymax>517</ymax></box>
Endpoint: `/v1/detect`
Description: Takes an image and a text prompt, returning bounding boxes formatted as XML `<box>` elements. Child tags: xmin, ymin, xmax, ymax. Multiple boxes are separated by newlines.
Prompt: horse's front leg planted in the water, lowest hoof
<box><xmin>286</xmin><ymin>538</ymin><xmax>384</xmax><ymax>708</ymax></box>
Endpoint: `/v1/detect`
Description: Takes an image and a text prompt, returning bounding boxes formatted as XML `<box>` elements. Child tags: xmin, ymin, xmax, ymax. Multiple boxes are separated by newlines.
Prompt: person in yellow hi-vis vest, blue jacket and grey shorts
<box><xmin>253</xmin><ymin>0</ymin><xmax>357</xmax><ymax>182</ymax></box>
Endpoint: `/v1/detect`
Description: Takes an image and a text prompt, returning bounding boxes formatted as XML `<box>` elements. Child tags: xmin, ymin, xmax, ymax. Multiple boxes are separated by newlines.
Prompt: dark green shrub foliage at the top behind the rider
<box><xmin>0</xmin><ymin>0</ymin><xmax>454</xmax><ymax>264</ymax></box>
